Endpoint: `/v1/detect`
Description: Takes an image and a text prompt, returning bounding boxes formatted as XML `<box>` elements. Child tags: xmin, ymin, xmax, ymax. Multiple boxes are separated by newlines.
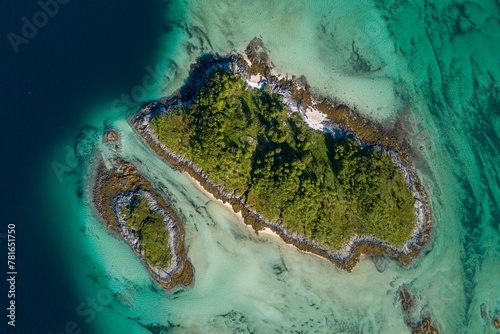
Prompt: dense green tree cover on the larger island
<box><xmin>150</xmin><ymin>70</ymin><xmax>416</xmax><ymax>251</ymax></box>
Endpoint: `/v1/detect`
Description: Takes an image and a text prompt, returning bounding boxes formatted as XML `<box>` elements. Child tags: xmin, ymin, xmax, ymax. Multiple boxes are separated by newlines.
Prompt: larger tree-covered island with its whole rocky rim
<box><xmin>133</xmin><ymin>40</ymin><xmax>431</xmax><ymax>270</ymax></box>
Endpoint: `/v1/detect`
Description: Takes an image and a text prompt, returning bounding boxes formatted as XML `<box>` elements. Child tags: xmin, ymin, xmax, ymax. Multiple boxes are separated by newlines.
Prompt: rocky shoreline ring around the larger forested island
<box><xmin>131</xmin><ymin>47</ymin><xmax>431</xmax><ymax>270</ymax></box>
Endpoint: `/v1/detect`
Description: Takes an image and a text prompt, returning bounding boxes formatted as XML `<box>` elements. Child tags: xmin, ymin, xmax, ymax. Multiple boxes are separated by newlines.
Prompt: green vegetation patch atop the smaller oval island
<box><xmin>120</xmin><ymin>195</ymin><xmax>172</xmax><ymax>268</ymax></box>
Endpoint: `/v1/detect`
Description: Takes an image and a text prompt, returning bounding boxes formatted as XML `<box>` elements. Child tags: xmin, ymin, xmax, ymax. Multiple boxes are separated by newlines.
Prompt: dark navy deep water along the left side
<box><xmin>0</xmin><ymin>0</ymin><xmax>174</xmax><ymax>333</ymax></box>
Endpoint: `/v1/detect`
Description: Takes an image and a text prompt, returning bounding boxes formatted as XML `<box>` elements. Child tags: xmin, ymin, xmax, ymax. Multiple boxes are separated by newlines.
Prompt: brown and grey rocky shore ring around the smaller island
<box><xmin>93</xmin><ymin>158</ymin><xmax>194</xmax><ymax>289</ymax></box>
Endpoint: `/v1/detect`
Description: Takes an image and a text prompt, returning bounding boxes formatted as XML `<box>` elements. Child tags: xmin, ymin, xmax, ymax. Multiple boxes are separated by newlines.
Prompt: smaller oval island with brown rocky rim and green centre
<box><xmin>93</xmin><ymin>155</ymin><xmax>193</xmax><ymax>289</ymax></box>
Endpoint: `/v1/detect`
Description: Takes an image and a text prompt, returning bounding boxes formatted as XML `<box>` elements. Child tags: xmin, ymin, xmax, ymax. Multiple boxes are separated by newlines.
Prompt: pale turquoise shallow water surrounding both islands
<box><xmin>48</xmin><ymin>0</ymin><xmax>500</xmax><ymax>333</ymax></box>
